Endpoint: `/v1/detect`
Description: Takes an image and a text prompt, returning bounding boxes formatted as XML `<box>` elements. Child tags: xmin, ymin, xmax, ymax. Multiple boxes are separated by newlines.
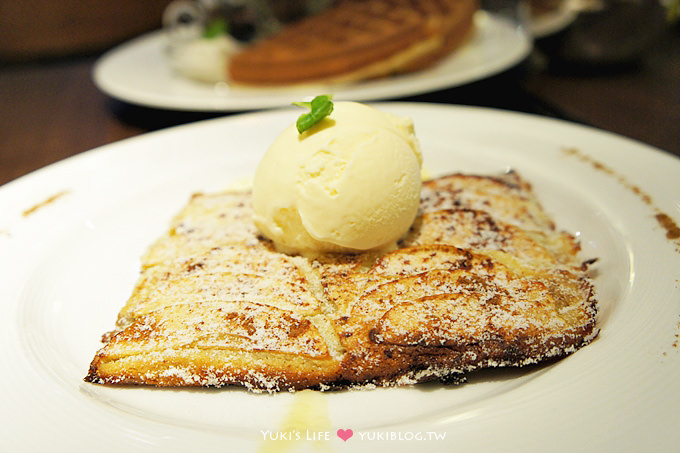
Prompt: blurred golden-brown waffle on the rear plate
<box><xmin>228</xmin><ymin>0</ymin><xmax>478</xmax><ymax>86</ymax></box>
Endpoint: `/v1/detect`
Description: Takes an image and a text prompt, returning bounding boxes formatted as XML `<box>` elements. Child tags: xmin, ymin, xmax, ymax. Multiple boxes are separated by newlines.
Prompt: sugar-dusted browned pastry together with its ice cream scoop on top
<box><xmin>86</xmin><ymin>103</ymin><xmax>598</xmax><ymax>392</ymax></box>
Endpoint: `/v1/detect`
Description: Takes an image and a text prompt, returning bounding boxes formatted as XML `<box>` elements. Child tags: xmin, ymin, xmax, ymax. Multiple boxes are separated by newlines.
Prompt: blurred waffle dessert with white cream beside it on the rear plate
<box><xmin>166</xmin><ymin>0</ymin><xmax>479</xmax><ymax>88</ymax></box>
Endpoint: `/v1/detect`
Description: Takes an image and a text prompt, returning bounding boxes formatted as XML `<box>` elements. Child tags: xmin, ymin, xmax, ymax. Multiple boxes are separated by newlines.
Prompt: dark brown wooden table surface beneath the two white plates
<box><xmin>0</xmin><ymin>20</ymin><xmax>680</xmax><ymax>185</ymax></box>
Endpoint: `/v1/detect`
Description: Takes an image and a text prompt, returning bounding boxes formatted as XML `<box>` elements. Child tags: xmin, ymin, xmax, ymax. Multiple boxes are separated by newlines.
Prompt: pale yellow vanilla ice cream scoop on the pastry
<box><xmin>253</xmin><ymin>102</ymin><xmax>422</xmax><ymax>253</ymax></box>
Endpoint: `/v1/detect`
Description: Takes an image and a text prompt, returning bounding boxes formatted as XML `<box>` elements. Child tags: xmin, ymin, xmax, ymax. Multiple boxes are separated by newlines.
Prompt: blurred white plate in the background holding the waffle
<box><xmin>93</xmin><ymin>12</ymin><xmax>531</xmax><ymax>111</ymax></box>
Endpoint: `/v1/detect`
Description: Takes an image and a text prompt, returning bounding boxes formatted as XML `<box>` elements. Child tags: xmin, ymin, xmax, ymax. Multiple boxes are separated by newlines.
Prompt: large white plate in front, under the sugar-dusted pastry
<box><xmin>0</xmin><ymin>103</ymin><xmax>680</xmax><ymax>453</ymax></box>
